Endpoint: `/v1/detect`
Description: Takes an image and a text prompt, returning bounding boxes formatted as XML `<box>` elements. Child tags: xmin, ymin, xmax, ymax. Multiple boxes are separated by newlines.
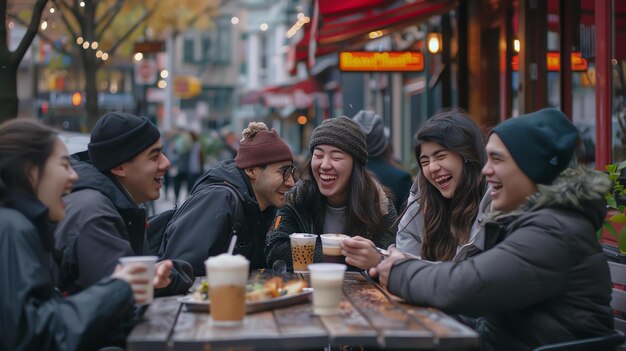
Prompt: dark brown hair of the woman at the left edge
<box><xmin>0</xmin><ymin>119</ymin><xmax>58</xmax><ymax>206</ymax></box>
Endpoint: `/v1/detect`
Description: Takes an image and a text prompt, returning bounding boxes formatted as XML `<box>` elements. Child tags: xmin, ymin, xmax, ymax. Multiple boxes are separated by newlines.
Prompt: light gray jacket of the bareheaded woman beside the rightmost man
<box><xmin>396</xmin><ymin>179</ymin><xmax>491</xmax><ymax>261</ymax></box>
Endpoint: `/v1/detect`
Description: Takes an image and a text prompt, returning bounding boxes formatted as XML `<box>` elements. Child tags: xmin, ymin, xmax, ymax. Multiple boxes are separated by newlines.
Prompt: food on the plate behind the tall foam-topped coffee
<box><xmin>192</xmin><ymin>277</ymin><xmax>307</xmax><ymax>302</ymax></box>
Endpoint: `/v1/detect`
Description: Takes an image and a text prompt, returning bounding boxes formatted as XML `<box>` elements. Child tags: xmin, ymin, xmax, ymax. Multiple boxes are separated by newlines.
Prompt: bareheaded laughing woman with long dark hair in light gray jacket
<box><xmin>396</xmin><ymin>109</ymin><xmax>491</xmax><ymax>261</ymax></box>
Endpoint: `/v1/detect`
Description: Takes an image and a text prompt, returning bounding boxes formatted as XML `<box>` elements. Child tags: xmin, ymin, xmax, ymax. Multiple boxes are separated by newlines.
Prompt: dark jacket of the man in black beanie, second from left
<box><xmin>55</xmin><ymin>152</ymin><xmax>193</xmax><ymax>296</ymax></box>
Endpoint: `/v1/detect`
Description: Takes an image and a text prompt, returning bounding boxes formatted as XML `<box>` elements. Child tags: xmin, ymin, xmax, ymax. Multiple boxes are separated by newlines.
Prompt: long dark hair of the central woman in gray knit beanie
<box><xmin>298</xmin><ymin>156</ymin><xmax>394</xmax><ymax>240</ymax></box>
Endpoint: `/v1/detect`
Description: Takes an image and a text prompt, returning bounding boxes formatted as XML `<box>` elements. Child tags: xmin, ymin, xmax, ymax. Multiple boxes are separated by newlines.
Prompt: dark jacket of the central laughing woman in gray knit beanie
<box><xmin>265</xmin><ymin>181</ymin><xmax>397</xmax><ymax>270</ymax></box>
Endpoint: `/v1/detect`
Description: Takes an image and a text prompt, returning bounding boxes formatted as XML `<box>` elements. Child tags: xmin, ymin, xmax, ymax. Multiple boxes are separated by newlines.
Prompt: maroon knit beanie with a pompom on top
<box><xmin>235</xmin><ymin>122</ymin><xmax>293</xmax><ymax>169</ymax></box>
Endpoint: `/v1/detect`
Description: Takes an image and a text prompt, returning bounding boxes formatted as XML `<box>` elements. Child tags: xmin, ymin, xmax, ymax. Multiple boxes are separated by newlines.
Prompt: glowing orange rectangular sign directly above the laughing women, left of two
<box><xmin>339</xmin><ymin>51</ymin><xmax>424</xmax><ymax>72</ymax></box>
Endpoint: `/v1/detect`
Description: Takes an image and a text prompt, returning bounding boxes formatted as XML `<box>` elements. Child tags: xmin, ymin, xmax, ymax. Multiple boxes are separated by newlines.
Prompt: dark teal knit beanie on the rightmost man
<box><xmin>492</xmin><ymin>108</ymin><xmax>578</xmax><ymax>184</ymax></box>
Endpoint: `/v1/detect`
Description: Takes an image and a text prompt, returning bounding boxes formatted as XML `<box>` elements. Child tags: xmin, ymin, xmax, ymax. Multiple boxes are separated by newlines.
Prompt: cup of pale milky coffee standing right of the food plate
<box><xmin>309</xmin><ymin>263</ymin><xmax>346</xmax><ymax>316</ymax></box>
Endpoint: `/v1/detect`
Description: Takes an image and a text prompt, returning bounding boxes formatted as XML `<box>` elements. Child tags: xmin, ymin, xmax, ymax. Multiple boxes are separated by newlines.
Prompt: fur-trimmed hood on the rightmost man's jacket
<box><xmin>489</xmin><ymin>166</ymin><xmax>611</xmax><ymax>227</ymax></box>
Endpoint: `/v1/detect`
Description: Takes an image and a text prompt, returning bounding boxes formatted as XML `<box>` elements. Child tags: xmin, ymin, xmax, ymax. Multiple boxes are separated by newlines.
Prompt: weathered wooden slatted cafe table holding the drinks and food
<box><xmin>127</xmin><ymin>271</ymin><xmax>478</xmax><ymax>351</ymax></box>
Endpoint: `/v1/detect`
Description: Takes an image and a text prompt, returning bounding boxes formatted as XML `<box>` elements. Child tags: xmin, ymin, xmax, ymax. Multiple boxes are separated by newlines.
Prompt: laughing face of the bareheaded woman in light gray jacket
<box><xmin>419</xmin><ymin>141</ymin><xmax>463</xmax><ymax>199</ymax></box>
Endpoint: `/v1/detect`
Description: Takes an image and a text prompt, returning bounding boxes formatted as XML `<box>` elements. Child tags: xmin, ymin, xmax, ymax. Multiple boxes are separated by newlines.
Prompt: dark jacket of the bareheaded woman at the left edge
<box><xmin>0</xmin><ymin>195</ymin><xmax>134</xmax><ymax>351</ymax></box>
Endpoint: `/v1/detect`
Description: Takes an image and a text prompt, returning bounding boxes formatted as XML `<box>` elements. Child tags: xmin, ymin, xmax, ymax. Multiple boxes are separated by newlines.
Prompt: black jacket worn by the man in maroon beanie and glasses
<box><xmin>159</xmin><ymin>160</ymin><xmax>276</xmax><ymax>276</ymax></box>
